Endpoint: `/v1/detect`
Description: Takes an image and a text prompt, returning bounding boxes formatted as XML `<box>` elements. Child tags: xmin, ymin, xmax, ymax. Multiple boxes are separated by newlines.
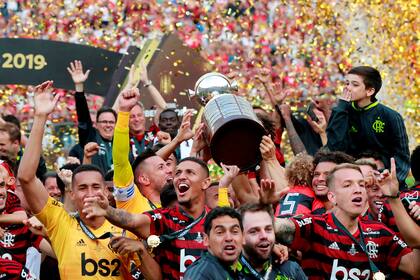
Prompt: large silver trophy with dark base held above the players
<box><xmin>188</xmin><ymin>72</ymin><xmax>266</xmax><ymax>171</ymax></box>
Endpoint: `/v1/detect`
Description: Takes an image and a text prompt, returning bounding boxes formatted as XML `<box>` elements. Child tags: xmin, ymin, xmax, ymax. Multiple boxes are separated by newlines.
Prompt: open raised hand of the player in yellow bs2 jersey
<box><xmin>34</xmin><ymin>81</ymin><xmax>60</xmax><ymax>116</ymax></box>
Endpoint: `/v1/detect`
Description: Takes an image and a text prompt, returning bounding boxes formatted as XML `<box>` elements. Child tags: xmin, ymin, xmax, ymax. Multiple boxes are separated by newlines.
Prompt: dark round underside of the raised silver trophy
<box><xmin>210</xmin><ymin>118</ymin><xmax>266</xmax><ymax>171</ymax></box>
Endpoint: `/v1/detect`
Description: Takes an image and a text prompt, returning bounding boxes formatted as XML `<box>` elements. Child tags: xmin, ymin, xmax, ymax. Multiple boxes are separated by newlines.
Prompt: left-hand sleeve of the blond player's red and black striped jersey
<box><xmin>290</xmin><ymin>215</ymin><xmax>314</xmax><ymax>252</ymax></box>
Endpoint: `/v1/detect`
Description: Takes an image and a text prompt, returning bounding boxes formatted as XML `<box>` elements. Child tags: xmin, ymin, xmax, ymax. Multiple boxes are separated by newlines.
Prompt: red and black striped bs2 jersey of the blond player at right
<box><xmin>291</xmin><ymin>213</ymin><xmax>411</xmax><ymax>280</ymax></box>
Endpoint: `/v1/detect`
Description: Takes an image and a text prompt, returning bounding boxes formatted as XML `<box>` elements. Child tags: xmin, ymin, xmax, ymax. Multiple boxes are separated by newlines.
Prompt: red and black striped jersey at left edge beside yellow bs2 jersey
<box><xmin>0</xmin><ymin>224</ymin><xmax>42</xmax><ymax>265</ymax></box>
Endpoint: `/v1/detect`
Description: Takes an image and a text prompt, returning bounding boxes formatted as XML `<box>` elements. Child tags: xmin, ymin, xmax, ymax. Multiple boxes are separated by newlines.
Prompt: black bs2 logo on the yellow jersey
<box><xmin>81</xmin><ymin>253</ymin><xmax>121</xmax><ymax>276</ymax></box>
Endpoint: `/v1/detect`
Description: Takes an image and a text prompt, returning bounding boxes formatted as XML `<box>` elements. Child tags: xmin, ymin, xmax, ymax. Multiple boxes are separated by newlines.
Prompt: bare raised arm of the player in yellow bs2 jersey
<box><xmin>18</xmin><ymin>81</ymin><xmax>60</xmax><ymax>213</ymax></box>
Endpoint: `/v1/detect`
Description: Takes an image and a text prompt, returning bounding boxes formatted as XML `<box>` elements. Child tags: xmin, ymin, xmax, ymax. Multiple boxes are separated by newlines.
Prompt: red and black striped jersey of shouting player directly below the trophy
<box><xmin>145</xmin><ymin>205</ymin><xmax>209</xmax><ymax>279</ymax></box>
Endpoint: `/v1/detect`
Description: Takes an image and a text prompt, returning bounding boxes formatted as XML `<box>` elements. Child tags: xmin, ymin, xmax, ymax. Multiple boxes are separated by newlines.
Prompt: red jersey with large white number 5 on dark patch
<box><xmin>276</xmin><ymin>186</ymin><xmax>325</xmax><ymax>217</ymax></box>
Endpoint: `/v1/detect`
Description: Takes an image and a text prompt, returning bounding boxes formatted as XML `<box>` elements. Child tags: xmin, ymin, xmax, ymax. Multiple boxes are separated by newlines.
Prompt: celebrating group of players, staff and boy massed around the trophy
<box><xmin>0</xmin><ymin>53</ymin><xmax>420</xmax><ymax>279</ymax></box>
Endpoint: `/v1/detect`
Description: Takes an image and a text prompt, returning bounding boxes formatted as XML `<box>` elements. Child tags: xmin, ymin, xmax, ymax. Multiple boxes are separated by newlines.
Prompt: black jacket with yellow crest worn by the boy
<box><xmin>327</xmin><ymin>100</ymin><xmax>410</xmax><ymax>186</ymax></box>
